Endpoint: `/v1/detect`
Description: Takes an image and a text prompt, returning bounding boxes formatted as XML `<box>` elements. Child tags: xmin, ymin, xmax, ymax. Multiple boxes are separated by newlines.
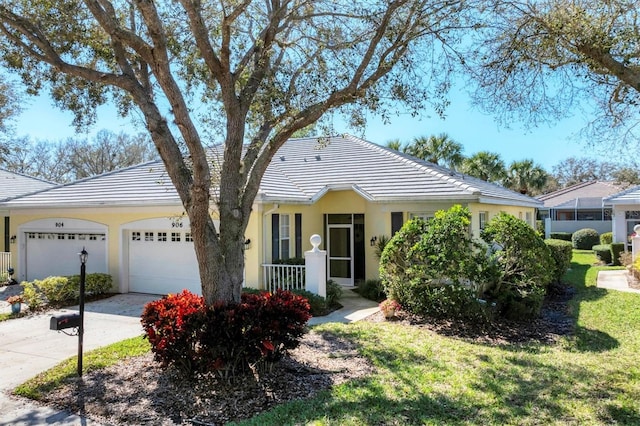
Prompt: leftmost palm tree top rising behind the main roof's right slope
<box><xmin>404</xmin><ymin>133</ymin><xmax>464</xmax><ymax>170</ymax></box>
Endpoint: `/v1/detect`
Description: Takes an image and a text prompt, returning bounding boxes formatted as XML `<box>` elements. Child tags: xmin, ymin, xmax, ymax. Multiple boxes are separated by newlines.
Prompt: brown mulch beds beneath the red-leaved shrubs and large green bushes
<box><xmin>28</xmin><ymin>286</ymin><xmax>574</xmax><ymax>425</ymax></box>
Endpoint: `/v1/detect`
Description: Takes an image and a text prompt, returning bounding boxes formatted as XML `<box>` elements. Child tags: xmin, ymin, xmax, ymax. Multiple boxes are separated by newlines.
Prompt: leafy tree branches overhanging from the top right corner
<box><xmin>465</xmin><ymin>0</ymin><xmax>640</xmax><ymax>142</ymax></box>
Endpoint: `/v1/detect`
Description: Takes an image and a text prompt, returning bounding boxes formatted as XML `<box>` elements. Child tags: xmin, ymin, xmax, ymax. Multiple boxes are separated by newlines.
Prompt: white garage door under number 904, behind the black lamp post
<box><xmin>25</xmin><ymin>232</ymin><xmax>107</xmax><ymax>281</ymax></box>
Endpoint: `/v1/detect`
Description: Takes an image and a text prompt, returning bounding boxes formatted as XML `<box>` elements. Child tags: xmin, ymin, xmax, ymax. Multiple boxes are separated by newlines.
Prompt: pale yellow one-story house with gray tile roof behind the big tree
<box><xmin>0</xmin><ymin>135</ymin><xmax>541</xmax><ymax>294</ymax></box>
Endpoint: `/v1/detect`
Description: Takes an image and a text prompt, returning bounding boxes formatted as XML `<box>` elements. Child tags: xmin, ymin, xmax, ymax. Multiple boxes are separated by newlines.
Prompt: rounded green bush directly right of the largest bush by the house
<box><xmin>481</xmin><ymin>212</ymin><xmax>555</xmax><ymax>320</ymax></box>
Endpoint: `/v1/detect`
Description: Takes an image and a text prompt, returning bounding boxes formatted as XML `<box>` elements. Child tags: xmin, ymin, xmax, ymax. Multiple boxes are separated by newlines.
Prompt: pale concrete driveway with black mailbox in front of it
<box><xmin>0</xmin><ymin>293</ymin><xmax>160</xmax><ymax>426</ymax></box>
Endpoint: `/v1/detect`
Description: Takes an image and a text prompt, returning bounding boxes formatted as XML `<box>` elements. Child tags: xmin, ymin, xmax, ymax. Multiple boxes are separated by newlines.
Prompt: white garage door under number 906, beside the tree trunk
<box><xmin>128</xmin><ymin>229</ymin><xmax>202</xmax><ymax>294</ymax></box>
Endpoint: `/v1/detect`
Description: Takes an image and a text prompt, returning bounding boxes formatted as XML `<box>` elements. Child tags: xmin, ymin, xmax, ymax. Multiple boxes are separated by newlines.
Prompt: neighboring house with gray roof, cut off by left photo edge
<box><xmin>0</xmin><ymin>169</ymin><xmax>56</xmax><ymax>255</ymax></box>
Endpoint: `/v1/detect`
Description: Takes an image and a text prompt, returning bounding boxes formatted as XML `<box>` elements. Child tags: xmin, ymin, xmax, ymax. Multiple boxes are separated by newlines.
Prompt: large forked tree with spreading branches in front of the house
<box><xmin>0</xmin><ymin>0</ymin><xmax>470</xmax><ymax>303</ymax></box>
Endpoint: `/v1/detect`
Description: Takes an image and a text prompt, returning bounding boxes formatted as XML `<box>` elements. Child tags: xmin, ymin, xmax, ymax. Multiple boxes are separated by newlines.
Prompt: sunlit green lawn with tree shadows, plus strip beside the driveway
<box><xmin>15</xmin><ymin>251</ymin><xmax>640</xmax><ymax>425</ymax></box>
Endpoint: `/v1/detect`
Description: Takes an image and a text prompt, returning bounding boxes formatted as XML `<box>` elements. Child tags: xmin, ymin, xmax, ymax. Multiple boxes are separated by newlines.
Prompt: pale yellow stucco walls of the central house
<box><xmin>0</xmin><ymin>195</ymin><xmax>535</xmax><ymax>290</ymax></box>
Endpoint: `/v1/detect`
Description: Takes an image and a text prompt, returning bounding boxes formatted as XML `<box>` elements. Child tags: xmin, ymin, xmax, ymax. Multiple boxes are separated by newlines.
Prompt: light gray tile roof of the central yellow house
<box><xmin>3</xmin><ymin>135</ymin><xmax>542</xmax><ymax>207</ymax></box>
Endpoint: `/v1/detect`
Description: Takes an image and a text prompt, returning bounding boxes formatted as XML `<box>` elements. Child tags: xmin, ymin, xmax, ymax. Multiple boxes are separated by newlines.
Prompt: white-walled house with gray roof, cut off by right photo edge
<box><xmin>604</xmin><ymin>186</ymin><xmax>640</xmax><ymax>248</ymax></box>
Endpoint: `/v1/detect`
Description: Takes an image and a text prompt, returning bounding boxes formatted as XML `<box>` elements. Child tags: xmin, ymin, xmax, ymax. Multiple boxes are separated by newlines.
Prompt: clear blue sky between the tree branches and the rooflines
<box><xmin>16</xmin><ymin>88</ymin><xmax>604</xmax><ymax>172</ymax></box>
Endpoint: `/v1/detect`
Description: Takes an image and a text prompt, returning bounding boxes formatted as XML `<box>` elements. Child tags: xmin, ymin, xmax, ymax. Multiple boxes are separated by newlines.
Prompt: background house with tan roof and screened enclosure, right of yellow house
<box><xmin>536</xmin><ymin>181</ymin><xmax>623</xmax><ymax>238</ymax></box>
